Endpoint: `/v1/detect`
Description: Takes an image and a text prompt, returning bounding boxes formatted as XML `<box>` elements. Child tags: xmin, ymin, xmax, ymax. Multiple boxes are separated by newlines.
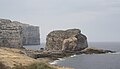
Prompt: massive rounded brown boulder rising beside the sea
<box><xmin>45</xmin><ymin>29</ymin><xmax>88</xmax><ymax>51</ymax></box>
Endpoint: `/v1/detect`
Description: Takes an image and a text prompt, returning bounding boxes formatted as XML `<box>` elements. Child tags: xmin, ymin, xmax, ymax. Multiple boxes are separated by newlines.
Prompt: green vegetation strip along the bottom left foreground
<box><xmin>0</xmin><ymin>62</ymin><xmax>55</xmax><ymax>69</ymax></box>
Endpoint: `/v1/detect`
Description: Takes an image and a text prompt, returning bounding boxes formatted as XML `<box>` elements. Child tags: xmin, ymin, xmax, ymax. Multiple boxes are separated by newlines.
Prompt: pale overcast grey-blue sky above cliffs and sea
<box><xmin>0</xmin><ymin>0</ymin><xmax>120</xmax><ymax>42</ymax></box>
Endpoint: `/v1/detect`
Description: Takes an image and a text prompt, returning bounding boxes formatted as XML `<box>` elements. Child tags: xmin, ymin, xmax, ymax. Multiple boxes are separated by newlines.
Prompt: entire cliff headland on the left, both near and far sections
<box><xmin>0</xmin><ymin>19</ymin><xmax>40</xmax><ymax>48</ymax></box>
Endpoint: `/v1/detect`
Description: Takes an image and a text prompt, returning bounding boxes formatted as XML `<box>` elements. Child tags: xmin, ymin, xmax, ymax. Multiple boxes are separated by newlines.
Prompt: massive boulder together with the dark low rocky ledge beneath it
<box><xmin>22</xmin><ymin>29</ymin><xmax>115</xmax><ymax>61</ymax></box>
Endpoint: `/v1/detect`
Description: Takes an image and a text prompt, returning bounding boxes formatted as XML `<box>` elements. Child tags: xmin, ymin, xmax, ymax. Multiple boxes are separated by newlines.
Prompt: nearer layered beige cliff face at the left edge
<box><xmin>0</xmin><ymin>19</ymin><xmax>22</xmax><ymax>48</ymax></box>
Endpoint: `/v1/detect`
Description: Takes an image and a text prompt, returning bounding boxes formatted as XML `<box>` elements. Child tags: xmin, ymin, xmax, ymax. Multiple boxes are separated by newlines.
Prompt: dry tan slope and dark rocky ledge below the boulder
<box><xmin>0</xmin><ymin>47</ymin><xmax>115</xmax><ymax>69</ymax></box>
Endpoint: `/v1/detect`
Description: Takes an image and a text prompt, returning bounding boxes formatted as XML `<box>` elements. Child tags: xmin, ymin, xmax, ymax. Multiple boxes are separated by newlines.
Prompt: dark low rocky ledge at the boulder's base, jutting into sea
<box><xmin>23</xmin><ymin>48</ymin><xmax>116</xmax><ymax>62</ymax></box>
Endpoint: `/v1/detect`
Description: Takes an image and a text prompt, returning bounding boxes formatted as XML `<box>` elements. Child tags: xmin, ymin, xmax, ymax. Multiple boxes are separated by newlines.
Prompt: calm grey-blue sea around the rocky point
<box><xmin>25</xmin><ymin>42</ymin><xmax>120</xmax><ymax>69</ymax></box>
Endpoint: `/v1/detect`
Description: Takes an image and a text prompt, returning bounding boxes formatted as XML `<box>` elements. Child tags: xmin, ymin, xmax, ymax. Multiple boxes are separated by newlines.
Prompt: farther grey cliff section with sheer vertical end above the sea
<box><xmin>13</xmin><ymin>21</ymin><xmax>40</xmax><ymax>45</ymax></box>
